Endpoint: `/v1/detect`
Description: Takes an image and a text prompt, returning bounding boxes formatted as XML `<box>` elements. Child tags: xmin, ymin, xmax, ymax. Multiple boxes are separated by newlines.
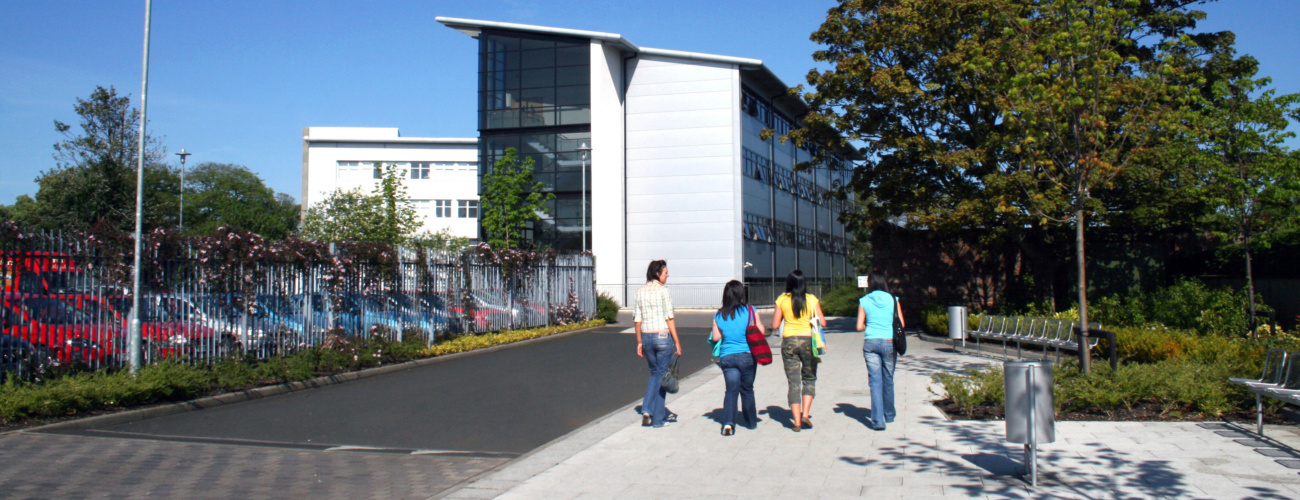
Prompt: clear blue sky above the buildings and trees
<box><xmin>0</xmin><ymin>0</ymin><xmax>1300</xmax><ymax>204</ymax></box>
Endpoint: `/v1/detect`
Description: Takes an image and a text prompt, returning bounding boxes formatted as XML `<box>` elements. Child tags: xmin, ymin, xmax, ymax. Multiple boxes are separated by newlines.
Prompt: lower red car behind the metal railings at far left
<box><xmin>0</xmin><ymin>294</ymin><xmax>124</xmax><ymax>365</ymax></box>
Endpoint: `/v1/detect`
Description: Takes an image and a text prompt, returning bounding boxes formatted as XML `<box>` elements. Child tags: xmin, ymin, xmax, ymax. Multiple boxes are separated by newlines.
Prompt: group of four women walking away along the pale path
<box><xmin>633</xmin><ymin>260</ymin><xmax>902</xmax><ymax>436</ymax></box>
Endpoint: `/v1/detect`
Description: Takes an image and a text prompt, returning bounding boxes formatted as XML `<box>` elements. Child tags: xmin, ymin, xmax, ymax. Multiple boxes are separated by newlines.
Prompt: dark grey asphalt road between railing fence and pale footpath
<box><xmin>55</xmin><ymin>322</ymin><xmax>710</xmax><ymax>457</ymax></box>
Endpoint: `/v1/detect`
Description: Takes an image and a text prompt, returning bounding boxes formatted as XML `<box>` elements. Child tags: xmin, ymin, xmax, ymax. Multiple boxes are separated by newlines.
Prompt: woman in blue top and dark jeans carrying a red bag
<box><xmin>711</xmin><ymin>279</ymin><xmax>767</xmax><ymax>436</ymax></box>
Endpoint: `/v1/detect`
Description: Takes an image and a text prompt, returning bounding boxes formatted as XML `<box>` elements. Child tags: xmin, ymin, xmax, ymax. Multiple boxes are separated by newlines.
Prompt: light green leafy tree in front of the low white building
<box><xmin>299</xmin><ymin>164</ymin><xmax>420</xmax><ymax>244</ymax></box>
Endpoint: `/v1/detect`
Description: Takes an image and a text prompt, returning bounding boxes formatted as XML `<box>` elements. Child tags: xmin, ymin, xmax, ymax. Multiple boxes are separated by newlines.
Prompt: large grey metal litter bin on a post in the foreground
<box><xmin>1002</xmin><ymin>361</ymin><xmax>1056</xmax><ymax>486</ymax></box>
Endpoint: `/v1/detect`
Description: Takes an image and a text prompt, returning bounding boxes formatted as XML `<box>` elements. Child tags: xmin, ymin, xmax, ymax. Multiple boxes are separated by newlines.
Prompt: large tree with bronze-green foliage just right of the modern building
<box><xmin>788</xmin><ymin>0</ymin><xmax>1232</xmax><ymax>368</ymax></box>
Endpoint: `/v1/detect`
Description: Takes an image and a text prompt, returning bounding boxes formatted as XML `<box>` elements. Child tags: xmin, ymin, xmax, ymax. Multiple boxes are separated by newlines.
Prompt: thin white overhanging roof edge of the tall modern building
<box><xmin>436</xmin><ymin>16</ymin><xmax>807</xmax><ymax>117</ymax></box>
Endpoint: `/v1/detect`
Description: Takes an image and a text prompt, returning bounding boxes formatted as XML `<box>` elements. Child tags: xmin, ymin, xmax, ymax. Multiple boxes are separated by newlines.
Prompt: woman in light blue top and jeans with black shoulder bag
<box><xmin>858</xmin><ymin>273</ymin><xmax>904</xmax><ymax>431</ymax></box>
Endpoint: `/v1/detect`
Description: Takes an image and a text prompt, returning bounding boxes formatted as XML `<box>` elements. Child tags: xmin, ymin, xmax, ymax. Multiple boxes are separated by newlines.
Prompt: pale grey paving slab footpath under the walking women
<box><xmin>439</xmin><ymin>318</ymin><xmax>1300</xmax><ymax>500</ymax></box>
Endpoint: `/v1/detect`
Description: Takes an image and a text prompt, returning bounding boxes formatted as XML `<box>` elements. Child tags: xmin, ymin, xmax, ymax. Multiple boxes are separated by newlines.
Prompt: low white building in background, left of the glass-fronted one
<box><xmin>303</xmin><ymin>127</ymin><xmax>478</xmax><ymax>239</ymax></box>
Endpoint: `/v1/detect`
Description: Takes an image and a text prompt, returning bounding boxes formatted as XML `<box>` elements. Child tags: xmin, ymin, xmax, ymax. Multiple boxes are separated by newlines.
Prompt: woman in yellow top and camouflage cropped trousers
<box><xmin>772</xmin><ymin>269</ymin><xmax>826</xmax><ymax>432</ymax></box>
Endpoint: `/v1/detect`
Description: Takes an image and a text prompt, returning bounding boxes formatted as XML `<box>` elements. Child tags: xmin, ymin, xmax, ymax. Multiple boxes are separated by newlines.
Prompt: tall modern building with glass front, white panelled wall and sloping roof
<box><xmin>438</xmin><ymin>17</ymin><xmax>853</xmax><ymax>306</ymax></box>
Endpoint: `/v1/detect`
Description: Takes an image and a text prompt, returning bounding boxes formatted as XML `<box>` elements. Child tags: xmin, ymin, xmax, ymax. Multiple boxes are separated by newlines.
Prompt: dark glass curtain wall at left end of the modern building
<box><xmin>478</xmin><ymin>31</ymin><xmax>592</xmax><ymax>251</ymax></box>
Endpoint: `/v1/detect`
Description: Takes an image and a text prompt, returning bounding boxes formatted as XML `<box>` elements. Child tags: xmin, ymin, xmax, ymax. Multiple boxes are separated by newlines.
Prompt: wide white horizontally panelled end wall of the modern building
<box><xmin>621</xmin><ymin>55</ymin><xmax>741</xmax><ymax>306</ymax></box>
